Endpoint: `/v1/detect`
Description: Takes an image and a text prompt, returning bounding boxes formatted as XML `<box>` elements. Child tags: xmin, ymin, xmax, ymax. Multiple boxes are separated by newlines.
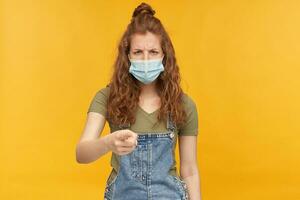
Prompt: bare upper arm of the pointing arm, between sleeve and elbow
<box><xmin>79</xmin><ymin>112</ymin><xmax>106</xmax><ymax>142</ymax></box>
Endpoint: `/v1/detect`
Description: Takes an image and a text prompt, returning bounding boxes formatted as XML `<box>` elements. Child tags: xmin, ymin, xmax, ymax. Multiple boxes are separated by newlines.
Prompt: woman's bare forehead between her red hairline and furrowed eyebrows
<box><xmin>131</xmin><ymin>32</ymin><xmax>161</xmax><ymax>49</ymax></box>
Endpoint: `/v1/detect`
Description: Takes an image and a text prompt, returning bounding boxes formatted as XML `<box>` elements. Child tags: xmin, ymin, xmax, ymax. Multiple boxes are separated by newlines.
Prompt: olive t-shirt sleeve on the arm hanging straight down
<box><xmin>178</xmin><ymin>95</ymin><xmax>198</xmax><ymax>136</ymax></box>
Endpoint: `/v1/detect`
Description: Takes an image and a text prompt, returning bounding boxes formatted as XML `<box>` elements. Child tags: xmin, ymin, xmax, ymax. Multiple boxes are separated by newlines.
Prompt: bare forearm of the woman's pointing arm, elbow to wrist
<box><xmin>76</xmin><ymin>135</ymin><xmax>110</xmax><ymax>163</ymax></box>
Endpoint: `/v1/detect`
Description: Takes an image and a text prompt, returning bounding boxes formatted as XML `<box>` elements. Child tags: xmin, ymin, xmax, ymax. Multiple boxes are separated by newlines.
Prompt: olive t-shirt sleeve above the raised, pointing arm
<box><xmin>87</xmin><ymin>87</ymin><xmax>108</xmax><ymax>117</ymax></box>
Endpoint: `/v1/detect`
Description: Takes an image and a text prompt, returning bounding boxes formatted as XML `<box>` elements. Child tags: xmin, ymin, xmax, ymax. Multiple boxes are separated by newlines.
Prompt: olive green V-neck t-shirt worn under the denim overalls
<box><xmin>87</xmin><ymin>86</ymin><xmax>198</xmax><ymax>181</ymax></box>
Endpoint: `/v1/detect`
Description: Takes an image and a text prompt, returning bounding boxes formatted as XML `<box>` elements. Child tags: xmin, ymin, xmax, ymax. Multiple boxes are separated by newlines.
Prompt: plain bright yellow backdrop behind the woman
<box><xmin>0</xmin><ymin>0</ymin><xmax>300</xmax><ymax>200</ymax></box>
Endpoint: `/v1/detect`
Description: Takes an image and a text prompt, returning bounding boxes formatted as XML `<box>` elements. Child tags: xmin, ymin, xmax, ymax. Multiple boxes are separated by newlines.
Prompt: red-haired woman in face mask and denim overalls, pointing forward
<box><xmin>76</xmin><ymin>3</ymin><xmax>200</xmax><ymax>200</ymax></box>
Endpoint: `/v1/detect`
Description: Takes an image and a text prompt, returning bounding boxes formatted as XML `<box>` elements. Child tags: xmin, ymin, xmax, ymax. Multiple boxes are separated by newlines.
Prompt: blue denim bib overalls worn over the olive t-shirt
<box><xmin>104</xmin><ymin>115</ymin><xmax>189</xmax><ymax>200</ymax></box>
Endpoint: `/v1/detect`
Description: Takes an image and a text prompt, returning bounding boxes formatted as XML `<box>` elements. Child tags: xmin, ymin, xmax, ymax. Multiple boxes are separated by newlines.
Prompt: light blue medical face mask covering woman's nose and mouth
<box><xmin>129</xmin><ymin>57</ymin><xmax>164</xmax><ymax>84</ymax></box>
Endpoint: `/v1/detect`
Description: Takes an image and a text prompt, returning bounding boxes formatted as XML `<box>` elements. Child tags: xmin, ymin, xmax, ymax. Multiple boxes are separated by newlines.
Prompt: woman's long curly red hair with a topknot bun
<box><xmin>107</xmin><ymin>3</ymin><xmax>186</xmax><ymax>127</ymax></box>
